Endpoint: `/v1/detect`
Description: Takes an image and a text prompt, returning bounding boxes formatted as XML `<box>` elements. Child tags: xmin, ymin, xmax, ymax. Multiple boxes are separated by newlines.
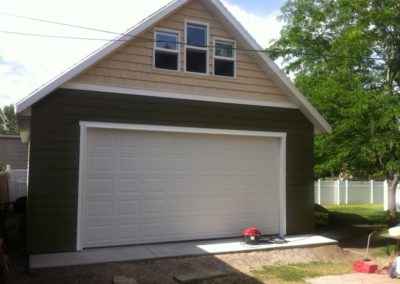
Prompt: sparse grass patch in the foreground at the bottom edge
<box><xmin>252</xmin><ymin>262</ymin><xmax>351</xmax><ymax>283</ymax></box>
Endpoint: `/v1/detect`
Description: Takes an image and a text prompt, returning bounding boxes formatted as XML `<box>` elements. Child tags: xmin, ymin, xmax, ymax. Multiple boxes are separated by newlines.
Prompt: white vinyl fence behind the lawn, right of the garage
<box><xmin>314</xmin><ymin>179</ymin><xmax>400</xmax><ymax>210</ymax></box>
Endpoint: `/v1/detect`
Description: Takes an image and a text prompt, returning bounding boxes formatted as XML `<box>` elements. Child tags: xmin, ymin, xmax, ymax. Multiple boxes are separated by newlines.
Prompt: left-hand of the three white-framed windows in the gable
<box><xmin>154</xmin><ymin>31</ymin><xmax>179</xmax><ymax>70</ymax></box>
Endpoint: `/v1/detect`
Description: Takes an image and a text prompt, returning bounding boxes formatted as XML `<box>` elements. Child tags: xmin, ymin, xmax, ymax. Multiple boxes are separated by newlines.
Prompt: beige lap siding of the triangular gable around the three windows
<box><xmin>72</xmin><ymin>0</ymin><xmax>289</xmax><ymax>106</ymax></box>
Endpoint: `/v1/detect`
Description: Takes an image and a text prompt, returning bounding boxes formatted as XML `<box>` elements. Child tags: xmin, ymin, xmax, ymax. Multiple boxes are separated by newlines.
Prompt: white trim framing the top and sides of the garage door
<box><xmin>76</xmin><ymin>121</ymin><xmax>287</xmax><ymax>251</ymax></box>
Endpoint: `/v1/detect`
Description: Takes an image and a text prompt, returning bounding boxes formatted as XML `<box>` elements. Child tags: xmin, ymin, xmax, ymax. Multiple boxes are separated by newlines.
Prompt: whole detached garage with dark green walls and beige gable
<box><xmin>17</xmin><ymin>0</ymin><xmax>330</xmax><ymax>260</ymax></box>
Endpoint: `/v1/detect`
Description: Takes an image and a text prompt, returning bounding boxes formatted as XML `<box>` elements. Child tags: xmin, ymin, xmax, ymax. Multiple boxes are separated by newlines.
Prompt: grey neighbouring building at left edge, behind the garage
<box><xmin>0</xmin><ymin>135</ymin><xmax>28</xmax><ymax>170</ymax></box>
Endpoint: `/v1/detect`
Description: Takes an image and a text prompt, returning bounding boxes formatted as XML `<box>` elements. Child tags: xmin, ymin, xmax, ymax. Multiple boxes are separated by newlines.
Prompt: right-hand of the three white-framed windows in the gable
<box><xmin>214</xmin><ymin>40</ymin><xmax>236</xmax><ymax>77</ymax></box>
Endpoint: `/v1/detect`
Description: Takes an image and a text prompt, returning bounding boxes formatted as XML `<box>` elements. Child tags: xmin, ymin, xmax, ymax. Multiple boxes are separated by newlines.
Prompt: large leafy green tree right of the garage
<box><xmin>267</xmin><ymin>0</ymin><xmax>400</xmax><ymax>218</ymax></box>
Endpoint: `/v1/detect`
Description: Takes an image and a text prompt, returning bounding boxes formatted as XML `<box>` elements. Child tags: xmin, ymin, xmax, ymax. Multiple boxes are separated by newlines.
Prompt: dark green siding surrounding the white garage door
<box><xmin>28</xmin><ymin>89</ymin><xmax>314</xmax><ymax>253</ymax></box>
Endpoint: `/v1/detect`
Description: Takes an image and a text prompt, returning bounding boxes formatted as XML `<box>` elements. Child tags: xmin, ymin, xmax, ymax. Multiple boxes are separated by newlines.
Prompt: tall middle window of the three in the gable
<box><xmin>186</xmin><ymin>23</ymin><xmax>208</xmax><ymax>74</ymax></box>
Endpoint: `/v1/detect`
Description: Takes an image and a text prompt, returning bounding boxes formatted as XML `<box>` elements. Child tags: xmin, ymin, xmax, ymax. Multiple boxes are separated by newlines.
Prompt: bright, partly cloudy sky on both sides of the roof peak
<box><xmin>0</xmin><ymin>0</ymin><xmax>284</xmax><ymax>106</ymax></box>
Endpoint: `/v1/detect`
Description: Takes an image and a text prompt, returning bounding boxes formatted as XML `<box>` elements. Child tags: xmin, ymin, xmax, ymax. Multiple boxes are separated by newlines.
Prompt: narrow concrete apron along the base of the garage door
<box><xmin>29</xmin><ymin>235</ymin><xmax>337</xmax><ymax>269</ymax></box>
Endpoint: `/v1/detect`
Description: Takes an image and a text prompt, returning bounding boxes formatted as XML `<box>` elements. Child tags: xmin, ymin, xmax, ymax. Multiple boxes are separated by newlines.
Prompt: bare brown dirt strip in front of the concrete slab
<box><xmin>7</xmin><ymin>245</ymin><xmax>350</xmax><ymax>284</ymax></box>
